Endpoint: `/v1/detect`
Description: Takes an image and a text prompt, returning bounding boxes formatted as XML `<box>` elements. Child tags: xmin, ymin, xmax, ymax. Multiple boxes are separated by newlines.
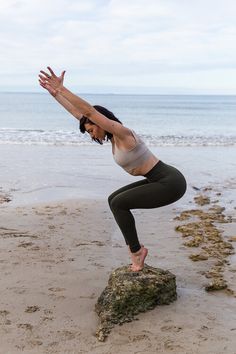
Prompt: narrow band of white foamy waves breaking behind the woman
<box><xmin>0</xmin><ymin>128</ymin><xmax>236</xmax><ymax>146</ymax></box>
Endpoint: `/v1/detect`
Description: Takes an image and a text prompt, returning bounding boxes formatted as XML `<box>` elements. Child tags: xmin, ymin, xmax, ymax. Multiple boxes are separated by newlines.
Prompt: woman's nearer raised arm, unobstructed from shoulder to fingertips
<box><xmin>40</xmin><ymin>67</ymin><xmax>130</xmax><ymax>139</ymax></box>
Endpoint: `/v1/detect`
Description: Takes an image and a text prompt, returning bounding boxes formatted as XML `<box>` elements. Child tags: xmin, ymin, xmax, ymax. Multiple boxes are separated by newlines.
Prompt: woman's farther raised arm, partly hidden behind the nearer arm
<box><xmin>39</xmin><ymin>71</ymin><xmax>83</xmax><ymax>120</ymax></box>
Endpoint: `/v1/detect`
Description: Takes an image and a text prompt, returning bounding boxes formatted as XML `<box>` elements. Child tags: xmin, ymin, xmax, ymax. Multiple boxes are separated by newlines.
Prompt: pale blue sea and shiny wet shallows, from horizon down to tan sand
<box><xmin>0</xmin><ymin>93</ymin><xmax>236</xmax><ymax>207</ymax></box>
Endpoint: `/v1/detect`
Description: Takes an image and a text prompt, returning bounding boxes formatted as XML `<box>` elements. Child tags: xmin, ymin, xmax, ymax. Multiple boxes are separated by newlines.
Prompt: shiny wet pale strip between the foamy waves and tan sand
<box><xmin>0</xmin><ymin>145</ymin><xmax>236</xmax><ymax>207</ymax></box>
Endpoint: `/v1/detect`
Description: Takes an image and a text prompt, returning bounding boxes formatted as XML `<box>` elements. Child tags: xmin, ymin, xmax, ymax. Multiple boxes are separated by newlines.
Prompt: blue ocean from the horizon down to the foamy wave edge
<box><xmin>0</xmin><ymin>93</ymin><xmax>236</xmax><ymax>147</ymax></box>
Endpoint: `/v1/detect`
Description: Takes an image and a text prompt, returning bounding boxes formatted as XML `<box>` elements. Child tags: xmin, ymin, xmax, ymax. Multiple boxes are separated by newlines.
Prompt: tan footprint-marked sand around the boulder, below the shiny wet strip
<box><xmin>0</xmin><ymin>191</ymin><xmax>236</xmax><ymax>354</ymax></box>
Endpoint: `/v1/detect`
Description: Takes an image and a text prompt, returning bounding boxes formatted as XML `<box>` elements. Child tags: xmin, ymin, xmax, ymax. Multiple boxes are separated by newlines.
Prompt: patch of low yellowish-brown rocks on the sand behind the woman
<box><xmin>175</xmin><ymin>187</ymin><xmax>236</xmax><ymax>291</ymax></box>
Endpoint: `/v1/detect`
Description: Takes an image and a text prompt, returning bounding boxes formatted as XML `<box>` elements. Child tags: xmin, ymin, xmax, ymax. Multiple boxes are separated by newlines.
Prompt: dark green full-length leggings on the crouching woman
<box><xmin>108</xmin><ymin>161</ymin><xmax>186</xmax><ymax>253</ymax></box>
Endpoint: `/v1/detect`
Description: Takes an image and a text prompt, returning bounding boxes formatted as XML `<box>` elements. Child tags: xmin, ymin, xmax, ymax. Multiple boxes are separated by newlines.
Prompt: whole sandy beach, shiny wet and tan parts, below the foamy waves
<box><xmin>0</xmin><ymin>145</ymin><xmax>236</xmax><ymax>354</ymax></box>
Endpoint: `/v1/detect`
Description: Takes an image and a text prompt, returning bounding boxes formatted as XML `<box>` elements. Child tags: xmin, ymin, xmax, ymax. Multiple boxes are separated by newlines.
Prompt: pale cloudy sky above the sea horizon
<box><xmin>0</xmin><ymin>0</ymin><xmax>236</xmax><ymax>94</ymax></box>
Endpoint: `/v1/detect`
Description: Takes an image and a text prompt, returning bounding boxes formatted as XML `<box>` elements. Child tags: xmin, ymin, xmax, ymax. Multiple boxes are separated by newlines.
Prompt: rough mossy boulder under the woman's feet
<box><xmin>95</xmin><ymin>264</ymin><xmax>177</xmax><ymax>341</ymax></box>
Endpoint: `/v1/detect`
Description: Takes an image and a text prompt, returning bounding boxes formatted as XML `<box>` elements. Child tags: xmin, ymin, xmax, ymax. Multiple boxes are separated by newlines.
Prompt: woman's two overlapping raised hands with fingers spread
<box><xmin>39</xmin><ymin>66</ymin><xmax>65</xmax><ymax>97</ymax></box>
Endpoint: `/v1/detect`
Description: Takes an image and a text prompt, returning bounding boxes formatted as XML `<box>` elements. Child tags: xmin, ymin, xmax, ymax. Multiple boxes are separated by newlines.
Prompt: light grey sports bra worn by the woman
<box><xmin>113</xmin><ymin>130</ymin><xmax>153</xmax><ymax>173</ymax></box>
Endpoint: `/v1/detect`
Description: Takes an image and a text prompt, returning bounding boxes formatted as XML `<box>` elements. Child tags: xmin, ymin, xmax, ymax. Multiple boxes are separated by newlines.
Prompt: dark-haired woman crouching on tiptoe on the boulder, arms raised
<box><xmin>39</xmin><ymin>67</ymin><xmax>186</xmax><ymax>272</ymax></box>
